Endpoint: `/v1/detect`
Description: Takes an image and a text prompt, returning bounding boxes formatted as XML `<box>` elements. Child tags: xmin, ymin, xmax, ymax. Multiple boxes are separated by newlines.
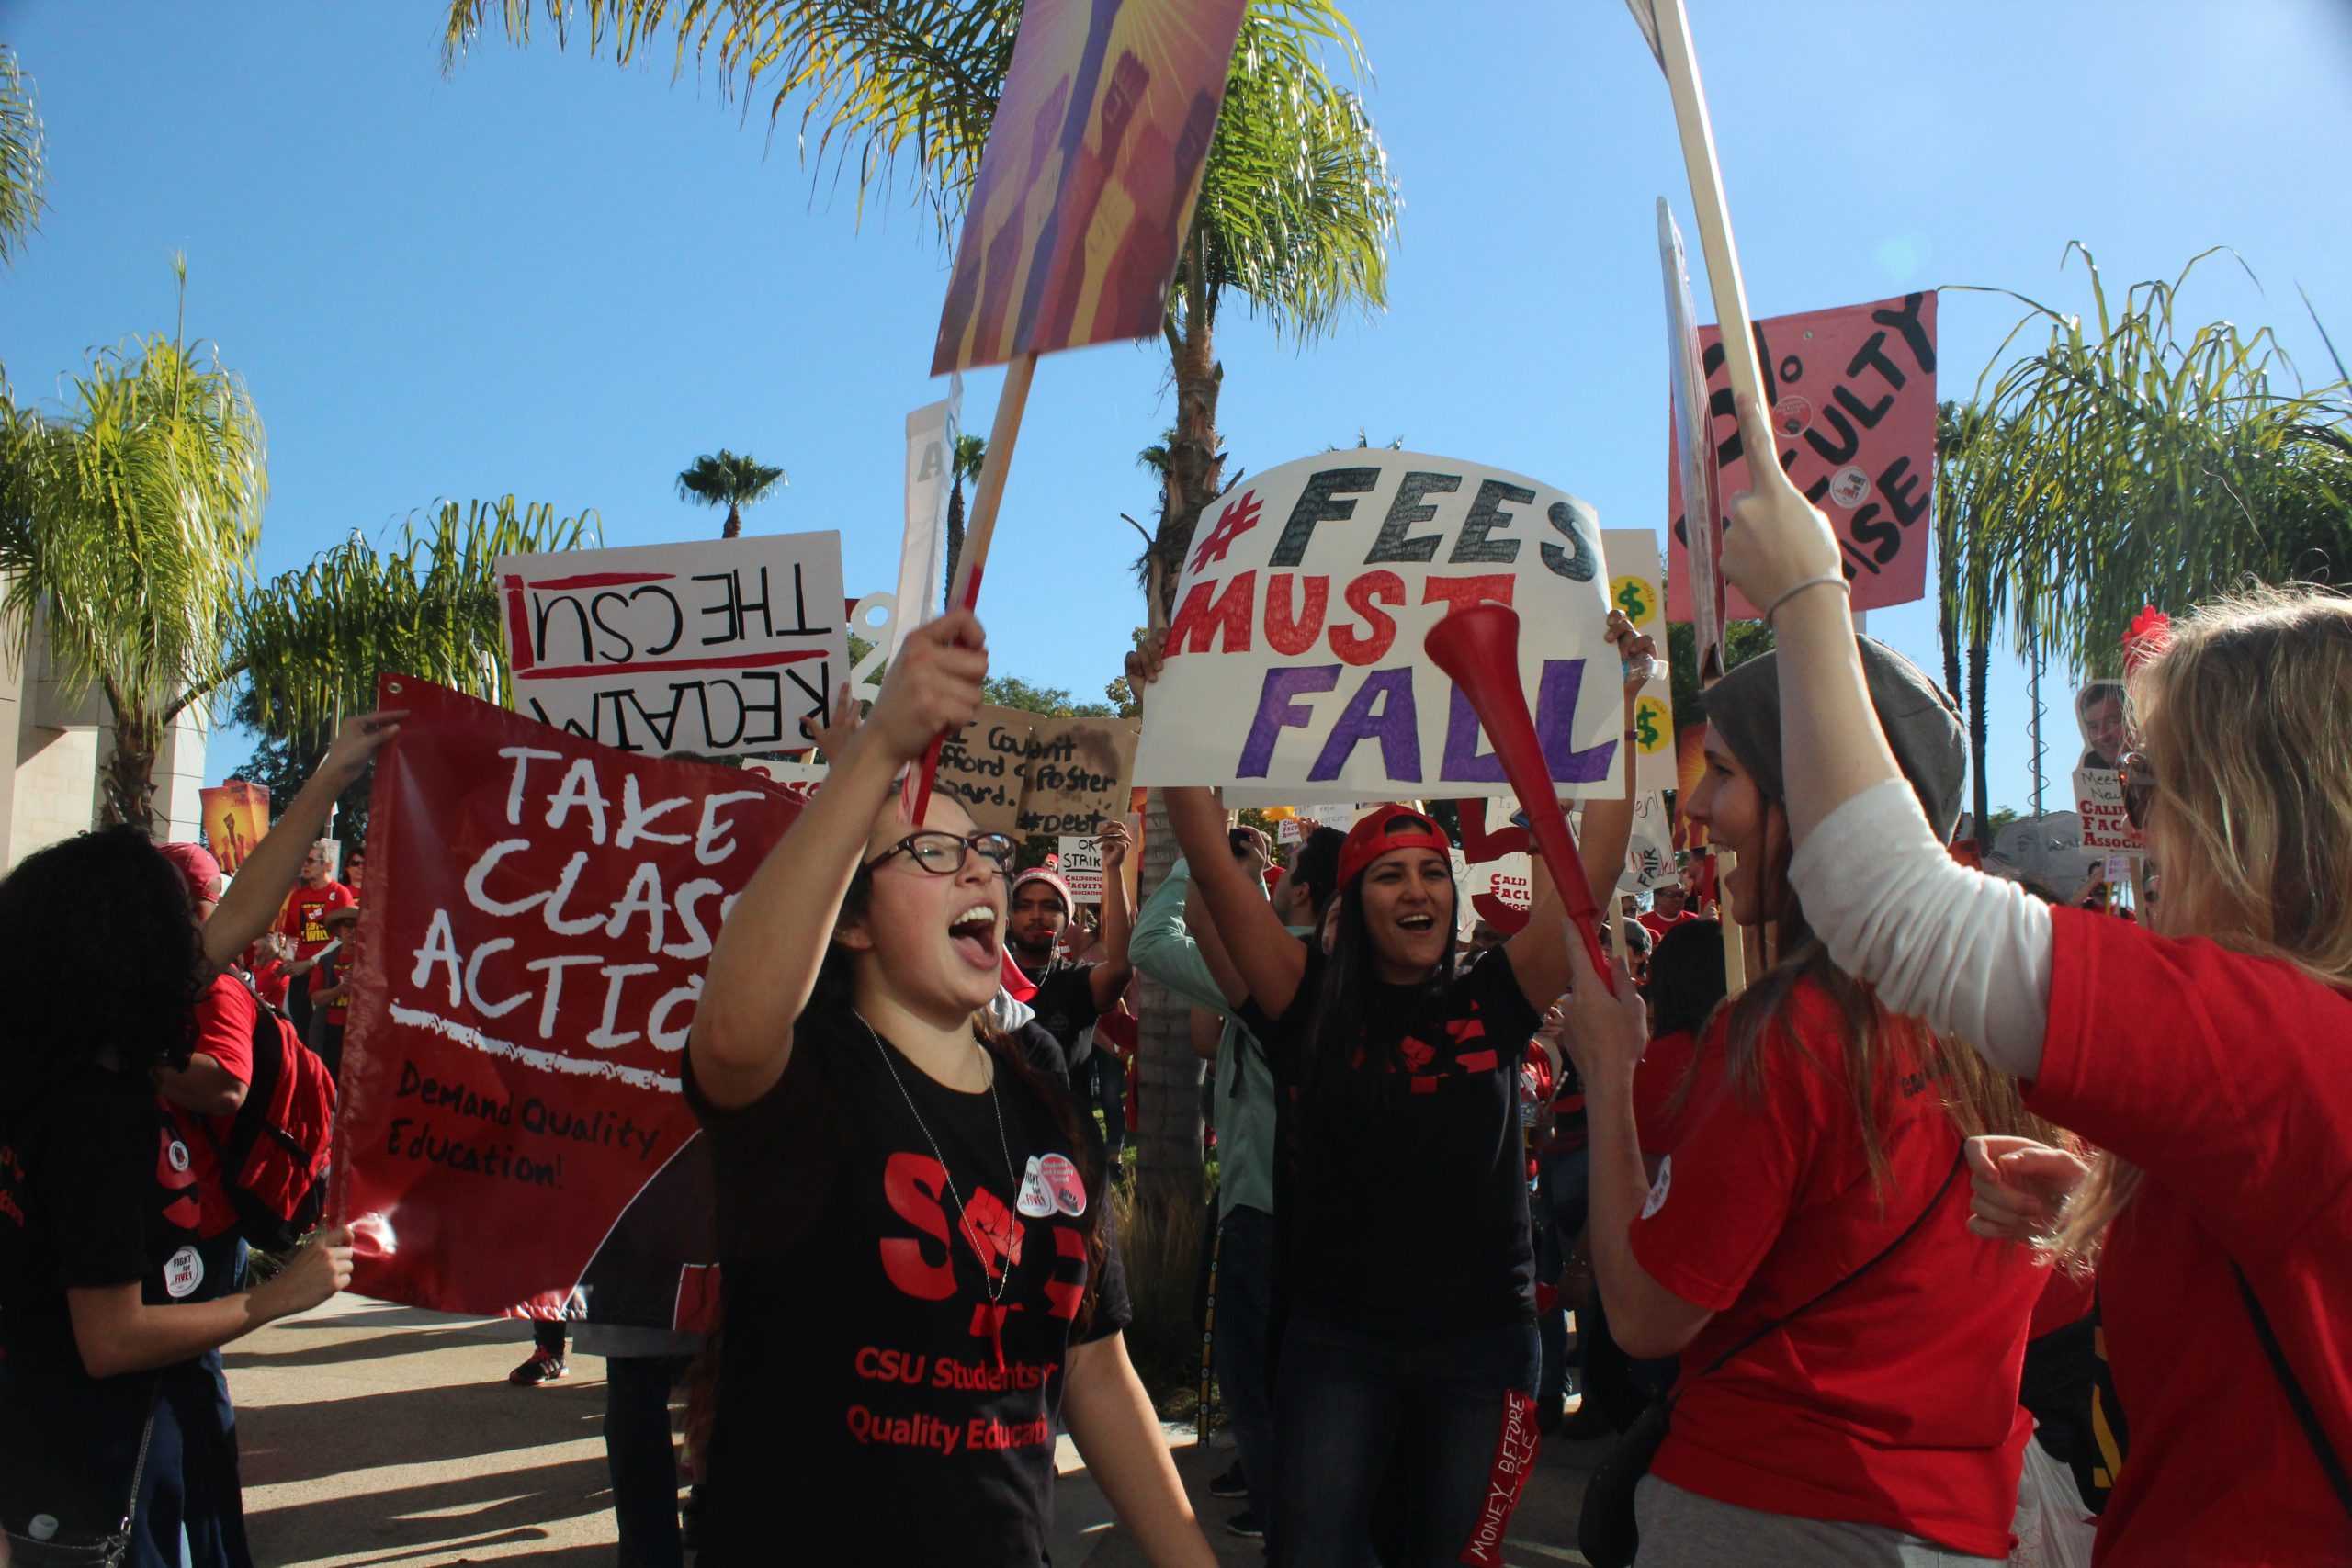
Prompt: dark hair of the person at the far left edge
<box><xmin>0</xmin><ymin>828</ymin><xmax>207</xmax><ymax>1122</ymax></box>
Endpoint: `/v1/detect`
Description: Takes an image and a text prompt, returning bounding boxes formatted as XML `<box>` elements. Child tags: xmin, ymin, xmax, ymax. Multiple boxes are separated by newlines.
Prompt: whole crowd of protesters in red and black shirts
<box><xmin>0</xmin><ymin>430</ymin><xmax>2352</xmax><ymax>1568</ymax></box>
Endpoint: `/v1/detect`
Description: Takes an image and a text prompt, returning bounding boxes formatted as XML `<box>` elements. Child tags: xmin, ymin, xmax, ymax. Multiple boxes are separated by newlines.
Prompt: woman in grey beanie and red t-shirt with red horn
<box><xmin>1566</xmin><ymin>594</ymin><xmax>2044</xmax><ymax>1568</ymax></box>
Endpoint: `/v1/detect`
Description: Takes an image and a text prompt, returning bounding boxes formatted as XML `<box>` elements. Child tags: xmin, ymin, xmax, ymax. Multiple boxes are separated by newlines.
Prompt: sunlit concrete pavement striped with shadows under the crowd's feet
<box><xmin>226</xmin><ymin>1295</ymin><xmax>1601</xmax><ymax>1568</ymax></box>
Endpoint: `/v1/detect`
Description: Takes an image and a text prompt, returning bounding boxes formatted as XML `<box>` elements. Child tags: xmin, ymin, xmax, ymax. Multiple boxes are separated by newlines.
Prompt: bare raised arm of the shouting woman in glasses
<box><xmin>687</xmin><ymin>611</ymin><xmax>988</xmax><ymax>1107</ymax></box>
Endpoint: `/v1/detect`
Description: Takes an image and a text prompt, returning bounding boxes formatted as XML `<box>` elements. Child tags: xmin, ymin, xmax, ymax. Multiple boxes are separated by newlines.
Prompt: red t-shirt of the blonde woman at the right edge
<box><xmin>2028</xmin><ymin>909</ymin><xmax>2352</xmax><ymax>1565</ymax></box>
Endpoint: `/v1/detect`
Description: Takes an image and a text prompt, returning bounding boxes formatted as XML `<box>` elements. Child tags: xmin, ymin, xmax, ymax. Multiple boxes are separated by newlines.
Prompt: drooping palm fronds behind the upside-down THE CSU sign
<box><xmin>235</xmin><ymin>496</ymin><xmax>600</xmax><ymax>745</ymax></box>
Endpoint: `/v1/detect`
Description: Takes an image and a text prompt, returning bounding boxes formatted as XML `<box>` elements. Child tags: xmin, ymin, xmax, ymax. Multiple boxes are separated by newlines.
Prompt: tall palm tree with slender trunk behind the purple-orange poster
<box><xmin>442</xmin><ymin>0</ymin><xmax>1399</xmax><ymax>1199</ymax></box>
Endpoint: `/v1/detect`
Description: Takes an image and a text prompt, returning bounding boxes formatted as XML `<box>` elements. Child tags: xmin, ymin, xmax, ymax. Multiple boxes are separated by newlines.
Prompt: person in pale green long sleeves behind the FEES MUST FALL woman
<box><xmin>1129</xmin><ymin>828</ymin><xmax>1345</xmax><ymax>1556</ymax></box>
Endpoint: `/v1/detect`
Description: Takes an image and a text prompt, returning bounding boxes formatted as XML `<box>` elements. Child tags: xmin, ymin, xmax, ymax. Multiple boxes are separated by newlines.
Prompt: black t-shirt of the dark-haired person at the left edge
<box><xmin>0</xmin><ymin>1065</ymin><xmax>238</xmax><ymax>1384</ymax></box>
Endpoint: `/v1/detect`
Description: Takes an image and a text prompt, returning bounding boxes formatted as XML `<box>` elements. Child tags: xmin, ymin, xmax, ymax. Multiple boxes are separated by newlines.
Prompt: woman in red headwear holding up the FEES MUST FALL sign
<box><xmin>1129</xmin><ymin>616</ymin><xmax>1651</xmax><ymax>1568</ymax></box>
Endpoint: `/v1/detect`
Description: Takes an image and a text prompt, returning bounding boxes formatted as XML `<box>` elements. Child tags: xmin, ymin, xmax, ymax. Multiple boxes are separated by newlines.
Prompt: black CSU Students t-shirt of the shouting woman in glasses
<box><xmin>684</xmin><ymin>1013</ymin><xmax>1129</xmax><ymax>1568</ymax></box>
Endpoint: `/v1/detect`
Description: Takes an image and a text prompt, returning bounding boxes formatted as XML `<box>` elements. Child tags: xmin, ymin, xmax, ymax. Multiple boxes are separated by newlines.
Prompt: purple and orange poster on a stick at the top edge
<box><xmin>932</xmin><ymin>0</ymin><xmax>1244</xmax><ymax>376</ymax></box>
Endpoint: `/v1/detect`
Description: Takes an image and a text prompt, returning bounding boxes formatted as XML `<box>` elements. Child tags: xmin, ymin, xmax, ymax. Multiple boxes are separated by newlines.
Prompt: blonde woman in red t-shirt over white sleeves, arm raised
<box><xmin>1724</xmin><ymin>389</ymin><xmax>2352</xmax><ymax>1563</ymax></box>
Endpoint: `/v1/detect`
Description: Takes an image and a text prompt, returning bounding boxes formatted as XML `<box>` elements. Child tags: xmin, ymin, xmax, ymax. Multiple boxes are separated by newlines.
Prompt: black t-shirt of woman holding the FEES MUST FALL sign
<box><xmin>1244</xmin><ymin>945</ymin><xmax>1543</xmax><ymax>1340</ymax></box>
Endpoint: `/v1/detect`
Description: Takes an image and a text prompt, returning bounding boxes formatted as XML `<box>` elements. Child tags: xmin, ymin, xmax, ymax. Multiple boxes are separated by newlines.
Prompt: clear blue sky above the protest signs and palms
<box><xmin>0</xmin><ymin>0</ymin><xmax>2352</xmax><ymax>807</ymax></box>
